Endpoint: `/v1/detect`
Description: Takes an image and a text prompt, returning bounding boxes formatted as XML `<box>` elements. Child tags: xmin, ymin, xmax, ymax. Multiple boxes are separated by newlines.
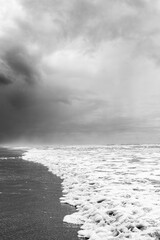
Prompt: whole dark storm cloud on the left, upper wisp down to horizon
<box><xmin>0</xmin><ymin>25</ymin><xmax>69</xmax><ymax>142</ymax></box>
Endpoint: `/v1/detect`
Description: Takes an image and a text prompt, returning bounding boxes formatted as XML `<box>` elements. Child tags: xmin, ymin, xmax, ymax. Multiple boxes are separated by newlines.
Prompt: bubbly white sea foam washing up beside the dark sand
<box><xmin>23</xmin><ymin>145</ymin><xmax>160</xmax><ymax>240</ymax></box>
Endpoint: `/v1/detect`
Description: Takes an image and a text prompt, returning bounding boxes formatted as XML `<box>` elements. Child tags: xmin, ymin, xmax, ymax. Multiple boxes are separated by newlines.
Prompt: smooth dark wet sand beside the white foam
<box><xmin>0</xmin><ymin>149</ymin><xmax>79</xmax><ymax>240</ymax></box>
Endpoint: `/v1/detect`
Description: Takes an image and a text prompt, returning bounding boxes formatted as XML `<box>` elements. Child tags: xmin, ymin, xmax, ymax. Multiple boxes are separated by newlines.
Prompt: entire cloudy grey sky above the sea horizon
<box><xmin>0</xmin><ymin>0</ymin><xmax>160</xmax><ymax>144</ymax></box>
